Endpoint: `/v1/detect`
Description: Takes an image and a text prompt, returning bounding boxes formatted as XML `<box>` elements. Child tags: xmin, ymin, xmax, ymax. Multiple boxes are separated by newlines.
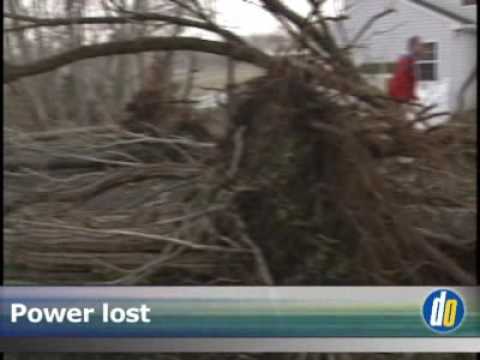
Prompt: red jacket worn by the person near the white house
<box><xmin>388</xmin><ymin>55</ymin><xmax>418</xmax><ymax>102</ymax></box>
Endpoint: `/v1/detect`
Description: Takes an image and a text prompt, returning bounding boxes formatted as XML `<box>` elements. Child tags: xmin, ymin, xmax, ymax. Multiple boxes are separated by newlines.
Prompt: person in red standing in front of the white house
<box><xmin>388</xmin><ymin>36</ymin><xmax>423</xmax><ymax>103</ymax></box>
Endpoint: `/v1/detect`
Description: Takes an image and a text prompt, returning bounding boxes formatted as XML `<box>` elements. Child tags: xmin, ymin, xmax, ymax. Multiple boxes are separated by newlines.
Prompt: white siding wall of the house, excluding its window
<box><xmin>345</xmin><ymin>0</ymin><xmax>476</xmax><ymax>106</ymax></box>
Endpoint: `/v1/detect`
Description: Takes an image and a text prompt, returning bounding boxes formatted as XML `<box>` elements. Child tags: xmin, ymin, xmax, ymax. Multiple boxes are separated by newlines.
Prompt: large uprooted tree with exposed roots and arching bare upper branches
<box><xmin>4</xmin><ymin>0</ymin><xmax>476</xmax><ymax>285</ymax></box>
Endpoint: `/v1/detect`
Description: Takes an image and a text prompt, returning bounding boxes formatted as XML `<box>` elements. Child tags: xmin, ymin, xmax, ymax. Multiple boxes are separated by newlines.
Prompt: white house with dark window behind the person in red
<box><xmin>335</xmin><ymin>0</ymin><xmax>477</xmax><ymax>111</ymax></box>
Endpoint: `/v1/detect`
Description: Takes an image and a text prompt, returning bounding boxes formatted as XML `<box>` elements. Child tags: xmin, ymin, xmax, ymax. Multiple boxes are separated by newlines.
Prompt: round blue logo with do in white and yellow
<box><xmin>422</xmin><ymin>289</ymin><xmax>466</xmax><ymax>334</ymax></box>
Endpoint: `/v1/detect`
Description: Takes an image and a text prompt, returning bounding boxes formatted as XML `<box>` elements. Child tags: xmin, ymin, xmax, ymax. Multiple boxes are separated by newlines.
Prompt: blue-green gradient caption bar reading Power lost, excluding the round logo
<box><xmin>0</xmin><ymin>287</ymin><xmax>480</xmax><ymax>340</ymax></box>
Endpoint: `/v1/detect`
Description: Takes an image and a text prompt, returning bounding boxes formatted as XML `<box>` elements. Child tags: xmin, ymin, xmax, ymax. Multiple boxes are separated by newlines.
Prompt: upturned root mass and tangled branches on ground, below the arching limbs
<box><xmin>6</xmin><ymin>71</ymin><xmax>475</xmax><ymax>285</ymax></box>
